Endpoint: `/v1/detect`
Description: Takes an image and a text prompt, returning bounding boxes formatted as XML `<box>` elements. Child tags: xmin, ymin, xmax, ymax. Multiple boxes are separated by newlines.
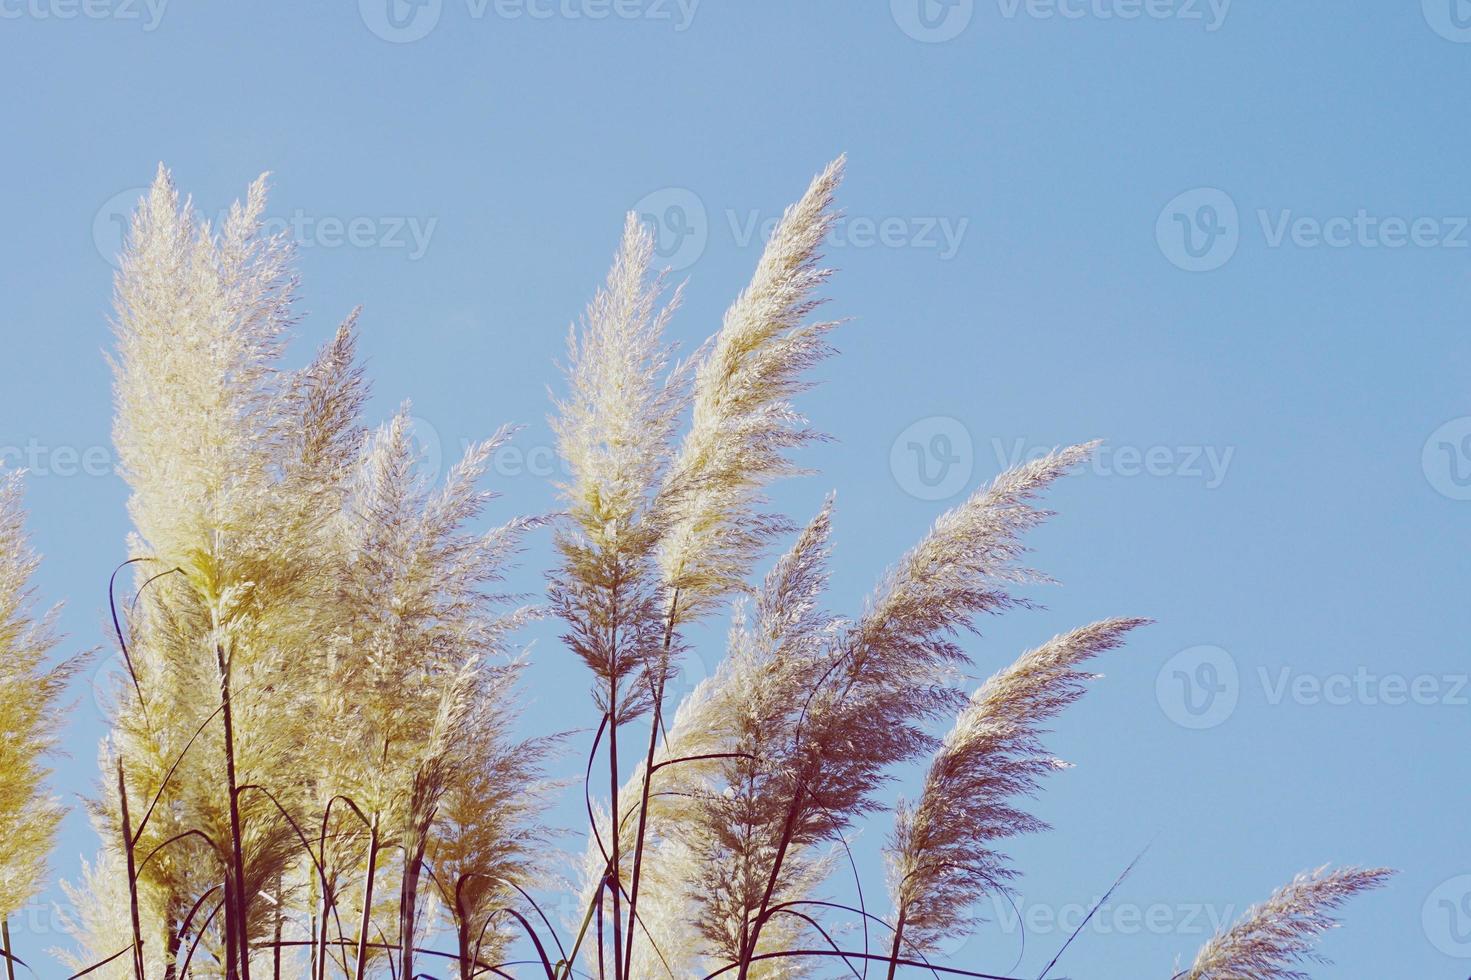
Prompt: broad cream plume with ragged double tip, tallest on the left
<box><xmin>113</xmin><ymin>166</ymin><xmax>294</xmax><ymax>576</ymax></box>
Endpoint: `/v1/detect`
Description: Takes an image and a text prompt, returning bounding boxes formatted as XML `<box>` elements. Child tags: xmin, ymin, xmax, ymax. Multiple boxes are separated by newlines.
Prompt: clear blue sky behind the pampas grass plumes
<box><xmin>0</xmin><ymin>0</ymin><xmax>1471</xmax><ymax>980</ymax></box>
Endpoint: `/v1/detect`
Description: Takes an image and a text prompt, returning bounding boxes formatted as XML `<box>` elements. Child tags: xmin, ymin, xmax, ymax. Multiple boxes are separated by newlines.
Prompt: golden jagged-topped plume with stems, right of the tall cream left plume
<box><xmin>328</xmin><ymin>409</ymin><xmax>537</xmax><ymax>976</ymax></box>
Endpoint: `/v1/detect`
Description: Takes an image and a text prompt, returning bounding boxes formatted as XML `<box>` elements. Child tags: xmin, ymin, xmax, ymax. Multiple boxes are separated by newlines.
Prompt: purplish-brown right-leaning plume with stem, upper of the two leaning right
<box><xmin>729</xmin><ymin>446</ymin><xmax>1091</xmax><ymax>976</ymax></box>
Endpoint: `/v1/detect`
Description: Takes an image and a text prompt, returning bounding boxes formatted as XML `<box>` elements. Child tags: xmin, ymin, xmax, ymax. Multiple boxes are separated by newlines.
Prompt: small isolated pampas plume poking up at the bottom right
<box><xmin>1174</xmin><ymin>865</ymin><xmax>1395</xmax><ymax>980</ymax></box>
